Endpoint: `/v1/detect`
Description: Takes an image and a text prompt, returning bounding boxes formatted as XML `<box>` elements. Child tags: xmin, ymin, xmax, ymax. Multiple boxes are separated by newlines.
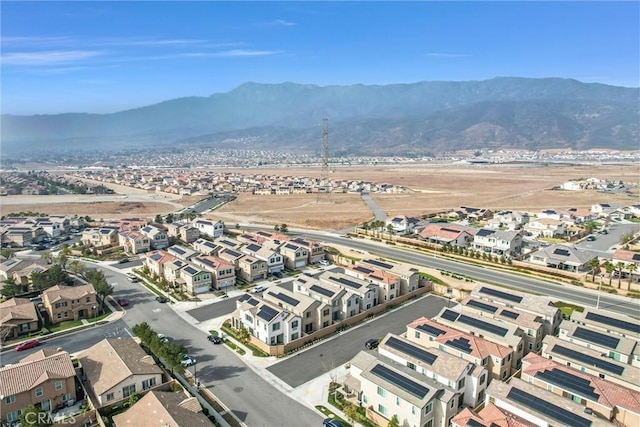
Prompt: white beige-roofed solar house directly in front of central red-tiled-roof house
<box><xmin>378</xmin><ymin>334</ymin><xmax>489</xmax><ymax>408</ymax></box>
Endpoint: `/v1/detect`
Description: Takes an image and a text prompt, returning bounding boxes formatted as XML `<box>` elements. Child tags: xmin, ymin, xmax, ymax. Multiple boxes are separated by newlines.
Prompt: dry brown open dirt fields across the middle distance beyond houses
<box><xmin>0</xmin><ymin>164</ymin><xmax>640</xmax><ymax>229</ymax></box>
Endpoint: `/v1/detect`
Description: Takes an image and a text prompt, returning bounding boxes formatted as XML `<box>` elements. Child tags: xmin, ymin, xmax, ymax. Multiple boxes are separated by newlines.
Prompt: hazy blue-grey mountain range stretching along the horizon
<box><xmin>1</xmin><ymin>77</ymin><xmax>640</xmax><ymax>156</ymax></box>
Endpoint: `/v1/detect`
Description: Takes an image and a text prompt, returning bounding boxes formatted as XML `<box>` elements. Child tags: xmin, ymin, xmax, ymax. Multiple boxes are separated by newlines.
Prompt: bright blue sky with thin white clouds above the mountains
<box><xmin>0</xmin><ymin>1</ymin><xmax>640</xmax><ymax>114</ymax></box>
